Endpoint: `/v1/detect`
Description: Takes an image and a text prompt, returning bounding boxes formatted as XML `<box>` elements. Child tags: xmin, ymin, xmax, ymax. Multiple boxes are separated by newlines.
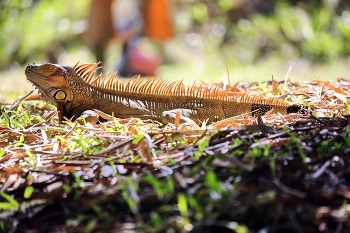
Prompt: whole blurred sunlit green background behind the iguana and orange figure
<box><xmin>0</xmin><ymin>0</ymin><xmax>350</xmax><ymax>102</ymax></box>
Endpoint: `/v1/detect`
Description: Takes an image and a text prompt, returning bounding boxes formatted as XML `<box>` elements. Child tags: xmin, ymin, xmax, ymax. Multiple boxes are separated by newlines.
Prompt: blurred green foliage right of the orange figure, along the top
<box><xmin>179</xmin><ymin>0</ymin><xmax>350</xmax><ymax>64</ymax></box>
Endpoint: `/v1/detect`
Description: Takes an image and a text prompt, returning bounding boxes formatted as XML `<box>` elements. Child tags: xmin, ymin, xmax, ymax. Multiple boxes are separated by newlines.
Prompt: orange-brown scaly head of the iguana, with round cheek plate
<box><xmin>25</xmin><ymin>63</ymin><xmax>73</xmax><ymax>104</ymax></box>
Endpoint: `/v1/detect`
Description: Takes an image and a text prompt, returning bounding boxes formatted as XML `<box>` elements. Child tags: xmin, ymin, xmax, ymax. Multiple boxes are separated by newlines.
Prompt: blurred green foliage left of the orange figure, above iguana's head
<box><xmin>0</xmin><ymin>0</ymin><xmax>89</xmax><ymax>68</ymax></box>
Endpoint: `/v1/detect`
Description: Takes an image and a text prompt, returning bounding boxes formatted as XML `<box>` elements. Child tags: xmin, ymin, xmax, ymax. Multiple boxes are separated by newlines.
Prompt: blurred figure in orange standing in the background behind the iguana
<box><xmin>87</xmin><ymin>0</ymin><xmax>174</xmax><ymax>77</ymax></box>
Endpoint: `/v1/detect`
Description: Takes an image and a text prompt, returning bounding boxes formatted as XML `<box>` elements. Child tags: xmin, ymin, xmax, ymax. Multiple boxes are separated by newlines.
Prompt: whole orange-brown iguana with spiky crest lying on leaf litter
<box><xmin>25</xmin><ymin>63</ymin><xmax>303</xmax><ymax>123</ymax></box>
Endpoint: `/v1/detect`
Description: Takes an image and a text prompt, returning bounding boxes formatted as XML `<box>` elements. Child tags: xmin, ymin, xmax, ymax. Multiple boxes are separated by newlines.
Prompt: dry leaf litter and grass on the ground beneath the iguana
<box><xmin>0</xmin><ymin>79</ymin><xmax>350</xmax><ymax>232</ymax></box>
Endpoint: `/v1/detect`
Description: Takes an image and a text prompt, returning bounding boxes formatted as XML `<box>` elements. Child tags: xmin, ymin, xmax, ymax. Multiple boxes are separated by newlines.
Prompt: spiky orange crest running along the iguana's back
<box><xmin>73</xmin><ymin>62</ymin><xmax>289</xmax><ymax>106</ymax></box>
